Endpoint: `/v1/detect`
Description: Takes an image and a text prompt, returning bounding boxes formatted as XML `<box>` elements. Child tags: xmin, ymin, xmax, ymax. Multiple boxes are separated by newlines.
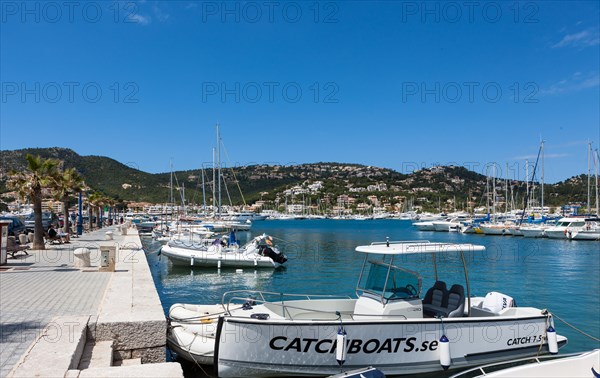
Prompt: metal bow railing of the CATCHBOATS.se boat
<box><xmin>221</xmin><ymin>290</ymin><xmax>353</xmax><ymax>320</ymax></box>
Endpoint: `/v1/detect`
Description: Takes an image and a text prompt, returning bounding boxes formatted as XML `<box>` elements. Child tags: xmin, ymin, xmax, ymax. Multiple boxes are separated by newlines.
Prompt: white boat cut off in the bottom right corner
<box><xmin>451</xmin><ymin>349</ymin><xmax>600</xmax><ymax>378</ymax></box>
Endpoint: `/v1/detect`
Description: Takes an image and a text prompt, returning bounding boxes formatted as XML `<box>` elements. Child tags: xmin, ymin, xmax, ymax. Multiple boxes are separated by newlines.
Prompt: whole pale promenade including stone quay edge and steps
<box><xmin>0</xmin><ymin>223</ymin><xmax>182</xmax><ymax>377</ymax></box>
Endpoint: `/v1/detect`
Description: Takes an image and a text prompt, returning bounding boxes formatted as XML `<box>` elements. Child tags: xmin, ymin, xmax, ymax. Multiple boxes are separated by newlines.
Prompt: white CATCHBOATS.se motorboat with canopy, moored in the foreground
<box><xmin>167</xmin><ymin>241</ymin><xmax>567</xmax><ymax>377</ymax></box>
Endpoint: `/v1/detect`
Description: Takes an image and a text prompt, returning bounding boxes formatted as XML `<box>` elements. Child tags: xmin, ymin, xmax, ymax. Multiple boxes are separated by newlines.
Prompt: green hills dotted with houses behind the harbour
<box><xmin>0</xmin><ymin>147</ymin><xmax>587</xmax><ymax>210</ymax></box>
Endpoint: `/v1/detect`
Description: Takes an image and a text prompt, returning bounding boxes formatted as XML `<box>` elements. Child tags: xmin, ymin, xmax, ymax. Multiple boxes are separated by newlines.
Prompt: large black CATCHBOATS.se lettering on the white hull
<box><xmin>269</xmin><ymin>336</ymin><xmax>438</xmax><ymax>354</ymax></box>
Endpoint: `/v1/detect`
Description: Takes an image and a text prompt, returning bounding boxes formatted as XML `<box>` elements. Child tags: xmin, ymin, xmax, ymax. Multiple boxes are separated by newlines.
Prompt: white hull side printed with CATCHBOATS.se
<box><xmin>215</xmin><ymin>308</ymin><xmax>566</xmax><ymax>377</ymax></box>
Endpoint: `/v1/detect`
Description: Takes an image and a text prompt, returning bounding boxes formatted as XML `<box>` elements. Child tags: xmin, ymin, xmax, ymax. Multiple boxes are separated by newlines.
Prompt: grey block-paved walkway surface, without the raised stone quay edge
<box><xmin>0</xmin><ymin>228</ymin><xmax>119</xmax><ymax>377</ymax></box>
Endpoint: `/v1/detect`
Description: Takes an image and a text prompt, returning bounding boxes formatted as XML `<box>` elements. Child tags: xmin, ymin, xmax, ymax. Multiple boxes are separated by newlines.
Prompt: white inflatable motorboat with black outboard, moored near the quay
<box><xmin>160</xmin><ymin>234</ymin><xmax>287</xmax><ymax>268</ymax></box>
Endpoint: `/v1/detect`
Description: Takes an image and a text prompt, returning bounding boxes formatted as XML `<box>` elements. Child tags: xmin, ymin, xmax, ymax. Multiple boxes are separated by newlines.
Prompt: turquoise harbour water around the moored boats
<box><xmin>143</xmin><ymin>220</ymin><xmax>600</xmax><ymax>353</ymax></box>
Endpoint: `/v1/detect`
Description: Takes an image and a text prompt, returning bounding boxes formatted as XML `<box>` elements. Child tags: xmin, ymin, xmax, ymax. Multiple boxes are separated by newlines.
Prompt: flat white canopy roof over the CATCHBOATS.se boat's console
<box><xmin>356</xmin><ymin>240</ymin><xmax>485</xmax><ymax>255</ymax></box>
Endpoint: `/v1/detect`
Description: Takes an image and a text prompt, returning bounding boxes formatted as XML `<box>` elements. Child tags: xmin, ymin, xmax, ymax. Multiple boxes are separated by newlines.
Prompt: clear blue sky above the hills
<box><xmin>0</xmin><ymin>0</ymin><xmax>600</xmax><ymax>182</ymax></box>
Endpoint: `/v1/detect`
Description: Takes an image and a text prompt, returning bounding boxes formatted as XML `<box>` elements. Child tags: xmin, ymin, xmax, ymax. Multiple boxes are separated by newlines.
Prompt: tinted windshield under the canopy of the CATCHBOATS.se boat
<box><xmin>358</xmin><ymin>260</ymin><xmax>421</xmax><ymax>302</ymax></box>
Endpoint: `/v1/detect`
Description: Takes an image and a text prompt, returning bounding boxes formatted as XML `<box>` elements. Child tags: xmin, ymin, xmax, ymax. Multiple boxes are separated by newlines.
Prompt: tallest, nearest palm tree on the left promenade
<box><xmin>7</xmin><ymin>154</ymin><xmax>59</xmax><ymax>249</ymax></box>
